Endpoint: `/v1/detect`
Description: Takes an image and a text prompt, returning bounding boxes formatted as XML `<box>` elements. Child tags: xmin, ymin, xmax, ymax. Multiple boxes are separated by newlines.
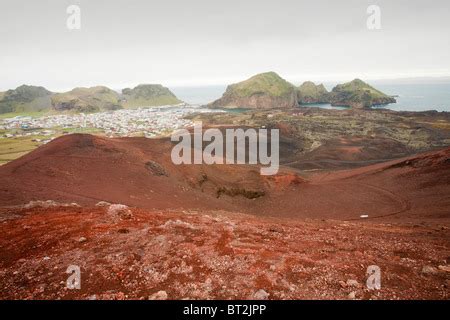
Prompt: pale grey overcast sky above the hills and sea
<box><xmin>0</xmin><ymin>0</ymin><xmax>450</xmax><ymax>91</ymax></box>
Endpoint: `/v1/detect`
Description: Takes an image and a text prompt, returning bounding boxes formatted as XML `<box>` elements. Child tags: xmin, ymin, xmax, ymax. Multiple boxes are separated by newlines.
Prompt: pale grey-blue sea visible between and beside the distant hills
<box><xmin>170</xmin><ymin>79</ymin><xmax>450</xmax><ymax>112</ymax></box>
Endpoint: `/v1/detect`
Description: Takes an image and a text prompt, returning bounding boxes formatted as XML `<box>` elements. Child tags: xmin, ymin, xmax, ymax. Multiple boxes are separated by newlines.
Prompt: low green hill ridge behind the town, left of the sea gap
<box><xmin>0</xmin><ymin>84</ymin><xmax>182</xmax><ymax>114</ymax></box>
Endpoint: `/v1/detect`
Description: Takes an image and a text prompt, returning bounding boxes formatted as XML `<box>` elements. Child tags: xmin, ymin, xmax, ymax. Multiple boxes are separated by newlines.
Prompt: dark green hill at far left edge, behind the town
<box><xmin>0</xmin><ymin>85</ymin><xmax>52</xmax><ymax>114</ymax></box>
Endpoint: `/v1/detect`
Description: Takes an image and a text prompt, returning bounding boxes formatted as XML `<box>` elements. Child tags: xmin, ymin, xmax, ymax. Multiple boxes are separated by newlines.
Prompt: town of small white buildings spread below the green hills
<box><xmin>0</xmin><ymin>104</ymin><xmax>224</xmax><ymax>138</ymax></box>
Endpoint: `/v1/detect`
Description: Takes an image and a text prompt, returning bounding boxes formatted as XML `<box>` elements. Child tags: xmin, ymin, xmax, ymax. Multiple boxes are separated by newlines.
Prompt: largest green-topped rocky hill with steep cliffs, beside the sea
<box><xmin>208</xmin><ymin>72</ymin><xmax>297</xmax><ymax>109</ymax></box>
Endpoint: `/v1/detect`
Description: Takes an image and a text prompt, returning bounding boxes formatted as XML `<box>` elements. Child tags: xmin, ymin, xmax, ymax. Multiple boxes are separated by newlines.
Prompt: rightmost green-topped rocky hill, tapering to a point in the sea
<box><xmin>330</xmin><ymin>79</ymin><xmax>396</xmax><ymax>108</ymax></box>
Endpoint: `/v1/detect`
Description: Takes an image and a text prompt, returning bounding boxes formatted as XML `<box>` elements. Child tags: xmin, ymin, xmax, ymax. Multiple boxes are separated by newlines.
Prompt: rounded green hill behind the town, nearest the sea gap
<box><xmin>121</xmin><ymin>84</ymin><xmax>182</xmax><ymax>108</ymax></box>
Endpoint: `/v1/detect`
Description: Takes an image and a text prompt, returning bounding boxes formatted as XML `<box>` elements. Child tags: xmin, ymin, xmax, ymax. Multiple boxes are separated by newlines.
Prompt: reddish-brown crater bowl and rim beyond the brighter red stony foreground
<box><xmin>0</xmin><ymin>134</ymin><xmax>450</xmax><ymax>219</ymax></box>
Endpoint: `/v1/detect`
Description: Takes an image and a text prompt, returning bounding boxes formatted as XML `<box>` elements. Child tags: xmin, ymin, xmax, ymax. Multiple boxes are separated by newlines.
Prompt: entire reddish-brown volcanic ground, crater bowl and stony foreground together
<box><xmin>0</xmin><ymin>135</ymin><xmax>450</xmax><ymax>299</ymax></box>
